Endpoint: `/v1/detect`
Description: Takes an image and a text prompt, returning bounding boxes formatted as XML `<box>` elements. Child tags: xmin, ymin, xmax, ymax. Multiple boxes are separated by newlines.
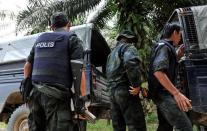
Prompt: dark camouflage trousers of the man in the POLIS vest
<box><xmin>28</xmin><ymin>88</ymin><xmax>74</xmax><ymax>131</ymax></box>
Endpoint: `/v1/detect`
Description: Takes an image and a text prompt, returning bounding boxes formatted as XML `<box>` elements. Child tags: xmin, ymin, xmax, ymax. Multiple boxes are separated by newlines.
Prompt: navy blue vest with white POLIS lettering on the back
<box><xmin>32</xmin><ymin>32</ymin><xmax>73</xmax><ymax>88</ymax></box>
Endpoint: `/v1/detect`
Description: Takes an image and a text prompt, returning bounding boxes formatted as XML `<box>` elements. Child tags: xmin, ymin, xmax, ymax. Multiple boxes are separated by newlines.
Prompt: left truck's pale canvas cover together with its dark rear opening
<box><xmin>0</xmin><ymin>23</ymin><xmax>110</xmax><ymax>66</ymax></box>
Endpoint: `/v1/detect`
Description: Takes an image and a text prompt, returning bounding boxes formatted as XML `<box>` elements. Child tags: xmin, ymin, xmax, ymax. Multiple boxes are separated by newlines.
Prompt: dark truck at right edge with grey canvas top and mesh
<box><xmin>163</xmin><ymin>5</ymin><xmax>207</xmax><ymax>131</ymax></box>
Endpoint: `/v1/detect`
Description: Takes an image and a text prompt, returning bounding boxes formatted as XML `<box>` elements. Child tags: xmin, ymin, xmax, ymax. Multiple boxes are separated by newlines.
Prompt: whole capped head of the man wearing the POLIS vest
<box><xmin>50</xmin><ymin>12</ymin><xmax>71</xmax><ymax>30</ymax></box>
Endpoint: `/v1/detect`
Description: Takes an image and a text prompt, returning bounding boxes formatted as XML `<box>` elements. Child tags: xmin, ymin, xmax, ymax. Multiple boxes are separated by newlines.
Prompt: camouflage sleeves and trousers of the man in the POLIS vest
<box><xmin>27</xmin><ymin>11</ymin><xmax>83</xmax><ymax>131</ymax></box>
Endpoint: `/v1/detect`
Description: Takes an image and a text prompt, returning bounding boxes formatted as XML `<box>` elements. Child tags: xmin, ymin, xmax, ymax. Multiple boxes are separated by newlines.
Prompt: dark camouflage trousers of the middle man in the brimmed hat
<box><xmin>111</xmin><ymin>87</ymin><xmax>146</xmax><ymax>131</ymax></box>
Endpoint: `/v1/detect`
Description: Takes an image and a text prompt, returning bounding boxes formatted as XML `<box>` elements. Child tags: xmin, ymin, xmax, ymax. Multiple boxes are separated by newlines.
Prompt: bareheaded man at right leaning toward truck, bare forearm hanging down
<box><xmin>149</xmin><ymin>23</ymin><xmax>192</xmax><ymax>131</ymax></box>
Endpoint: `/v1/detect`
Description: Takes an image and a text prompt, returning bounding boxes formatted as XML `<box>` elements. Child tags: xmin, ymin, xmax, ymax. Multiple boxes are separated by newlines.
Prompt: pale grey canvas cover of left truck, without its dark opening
<box><xmin>0</xmin><ymin>24</ymin><xmax>93</xmax><ymax>64</ymax></box>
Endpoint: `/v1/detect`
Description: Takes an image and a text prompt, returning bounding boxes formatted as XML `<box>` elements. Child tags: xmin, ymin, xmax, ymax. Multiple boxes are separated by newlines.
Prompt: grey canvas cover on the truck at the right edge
<box><xmin>191</xmin><ymin>5</ymin><xmax>207</xmax><ymax>50</ymax></box>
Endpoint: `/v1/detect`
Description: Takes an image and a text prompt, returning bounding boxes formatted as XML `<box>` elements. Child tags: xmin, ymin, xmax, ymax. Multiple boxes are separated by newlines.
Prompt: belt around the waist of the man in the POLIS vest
<box><xmin>32</xmin><ymin>82</ymin><xmax>73</xmax><ymax>101</ymax></box>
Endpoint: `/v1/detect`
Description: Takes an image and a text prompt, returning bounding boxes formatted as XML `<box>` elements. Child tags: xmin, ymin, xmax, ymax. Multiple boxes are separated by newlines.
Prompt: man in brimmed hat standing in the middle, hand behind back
<box><xmin>106</xmin><ymin>30</ymin><xmax>146</xmax><ymax>131</ymax></box>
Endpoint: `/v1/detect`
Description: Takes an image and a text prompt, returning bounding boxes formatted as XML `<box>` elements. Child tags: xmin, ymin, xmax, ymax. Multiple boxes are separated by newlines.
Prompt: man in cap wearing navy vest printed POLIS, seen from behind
<box><xmin>24</xmin><ymin>12</ymin><xmax>83</xmax><ymax>131</ymax></box>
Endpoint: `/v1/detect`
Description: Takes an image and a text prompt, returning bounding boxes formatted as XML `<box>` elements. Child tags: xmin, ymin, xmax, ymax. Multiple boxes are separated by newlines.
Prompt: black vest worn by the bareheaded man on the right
<box><xmin>148</xmin><ymin>40</ymin><xmax>177</xmax><ymax>98</ymax></box>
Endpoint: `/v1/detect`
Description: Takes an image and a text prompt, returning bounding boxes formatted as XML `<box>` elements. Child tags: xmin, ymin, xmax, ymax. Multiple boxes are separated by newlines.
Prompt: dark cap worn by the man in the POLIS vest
<box><xmin>50</xmin><ymin>12</ymin><xmax>69</xmax><ymax>28</ymax></box>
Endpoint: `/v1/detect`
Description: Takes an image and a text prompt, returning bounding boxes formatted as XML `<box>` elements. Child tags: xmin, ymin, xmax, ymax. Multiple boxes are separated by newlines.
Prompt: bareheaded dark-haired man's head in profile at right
<box><xmin>162</xmin><ymin>23</ymin><xmax>182</xmax><ymax>45</ymax></box>
